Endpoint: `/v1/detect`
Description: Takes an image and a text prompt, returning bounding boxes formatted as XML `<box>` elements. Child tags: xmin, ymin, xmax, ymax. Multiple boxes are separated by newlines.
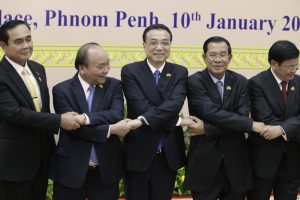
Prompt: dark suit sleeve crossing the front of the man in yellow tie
<box><xmin>0</xmin><ymin>77</ymin><xmax>60</xmax><ymax>133</ymax></box>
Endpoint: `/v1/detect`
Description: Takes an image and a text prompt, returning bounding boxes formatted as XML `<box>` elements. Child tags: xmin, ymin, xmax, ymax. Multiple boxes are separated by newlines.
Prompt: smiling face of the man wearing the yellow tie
<box><xmin>1</xmin><ymin>24</ymin><xmax>33</xmax><ymax>66</ymax></box>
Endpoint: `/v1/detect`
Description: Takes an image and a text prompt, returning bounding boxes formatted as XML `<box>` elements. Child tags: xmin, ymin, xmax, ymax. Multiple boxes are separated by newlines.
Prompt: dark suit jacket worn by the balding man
<box><xmin>50</xmin><ymin>73</ymin><xmax>124</xmax><ymax>188</ymax></box>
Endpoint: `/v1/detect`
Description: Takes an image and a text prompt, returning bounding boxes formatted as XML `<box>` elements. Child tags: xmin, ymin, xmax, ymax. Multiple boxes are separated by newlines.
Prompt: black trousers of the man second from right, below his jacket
<box><xmin>192</xmin><ymin>162</ymin><xmax>245</xmax><ymax>200</ymax></box>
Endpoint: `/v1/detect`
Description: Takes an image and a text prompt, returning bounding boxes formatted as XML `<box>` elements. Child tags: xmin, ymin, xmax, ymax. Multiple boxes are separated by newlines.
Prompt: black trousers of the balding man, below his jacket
<box><xmin>53</xmin><ymin>167</ymin><xmax>119</xmax><ymax>200</ymax></box>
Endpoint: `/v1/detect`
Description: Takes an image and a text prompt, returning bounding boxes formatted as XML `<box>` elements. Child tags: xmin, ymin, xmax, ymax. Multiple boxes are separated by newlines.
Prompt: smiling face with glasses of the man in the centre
<box><xmin>143</xmin><ymin>29</ymin><xmax>171</xmax><ymax>68</ymax></box>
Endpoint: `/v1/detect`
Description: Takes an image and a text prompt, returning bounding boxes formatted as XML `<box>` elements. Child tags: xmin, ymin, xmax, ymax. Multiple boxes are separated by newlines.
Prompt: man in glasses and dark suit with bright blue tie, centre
<box><xmin>121</xmin><ymin>24</ymin><xmax>192</xmax><ymax>200</ymax></box>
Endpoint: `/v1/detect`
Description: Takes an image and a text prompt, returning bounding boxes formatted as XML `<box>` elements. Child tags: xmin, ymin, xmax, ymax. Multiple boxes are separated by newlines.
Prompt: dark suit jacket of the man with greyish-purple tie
<box><xmin>184</xmin><ymin>69</ymin><xmax>252</xmax><ymax>193</ymax></box>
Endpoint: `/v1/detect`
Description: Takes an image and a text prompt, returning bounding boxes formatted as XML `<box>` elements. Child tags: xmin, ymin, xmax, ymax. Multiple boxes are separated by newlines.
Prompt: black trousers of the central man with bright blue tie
<box><xmin>125</xmin><ymin>152</ymin><xmax>177</xmax><ymax>200</ymax></box>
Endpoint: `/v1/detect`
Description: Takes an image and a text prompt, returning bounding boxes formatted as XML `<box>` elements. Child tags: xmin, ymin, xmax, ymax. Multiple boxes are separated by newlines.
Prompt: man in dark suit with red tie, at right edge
<box><xmin>248</xmin><ymin>41</ymin><xmax>300</xmax><ymax>200</ymax></box>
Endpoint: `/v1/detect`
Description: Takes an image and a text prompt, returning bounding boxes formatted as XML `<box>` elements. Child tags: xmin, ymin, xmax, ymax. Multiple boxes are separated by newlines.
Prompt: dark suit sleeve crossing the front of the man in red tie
<box><xmin>250</xmin><ymin>78</ymin><xmax>300</xmax><ymax>141</ymax></box>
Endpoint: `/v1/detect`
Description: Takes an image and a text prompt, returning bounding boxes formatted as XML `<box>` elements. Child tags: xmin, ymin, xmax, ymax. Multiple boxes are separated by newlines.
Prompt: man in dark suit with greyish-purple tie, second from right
<box><xmin>184</xmin><ymin>36</ymin><xmax>263</xmax><ymax>200</ymax></box>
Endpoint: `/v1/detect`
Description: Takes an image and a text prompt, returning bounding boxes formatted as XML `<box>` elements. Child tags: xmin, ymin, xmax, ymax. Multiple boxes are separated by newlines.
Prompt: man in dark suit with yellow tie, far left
<box><xmin>0</xmin><ymin>20</ymin><xmax>80</xmax><ymax>200</ymax></box>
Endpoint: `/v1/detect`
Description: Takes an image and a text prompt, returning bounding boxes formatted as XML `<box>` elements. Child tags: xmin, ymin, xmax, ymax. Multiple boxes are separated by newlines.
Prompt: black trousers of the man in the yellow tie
<box><xmin>0</xmin><ymin>167</ymin><xmax>48</xmax><ymax>200</ymax></box>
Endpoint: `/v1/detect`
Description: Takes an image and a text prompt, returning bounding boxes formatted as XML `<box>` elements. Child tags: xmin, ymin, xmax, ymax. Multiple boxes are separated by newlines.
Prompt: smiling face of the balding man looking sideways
<box><xmin>79</xmin><ymin>47</ymin><xmax>110</xmax><ymax>85</ymax></box>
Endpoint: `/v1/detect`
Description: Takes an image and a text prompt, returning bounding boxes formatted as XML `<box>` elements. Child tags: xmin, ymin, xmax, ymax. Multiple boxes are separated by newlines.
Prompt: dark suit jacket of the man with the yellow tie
<box><xmin>0</xmin><ymin>57</ymin><xmax>60</xmax><ymax>182</ymax></box>
